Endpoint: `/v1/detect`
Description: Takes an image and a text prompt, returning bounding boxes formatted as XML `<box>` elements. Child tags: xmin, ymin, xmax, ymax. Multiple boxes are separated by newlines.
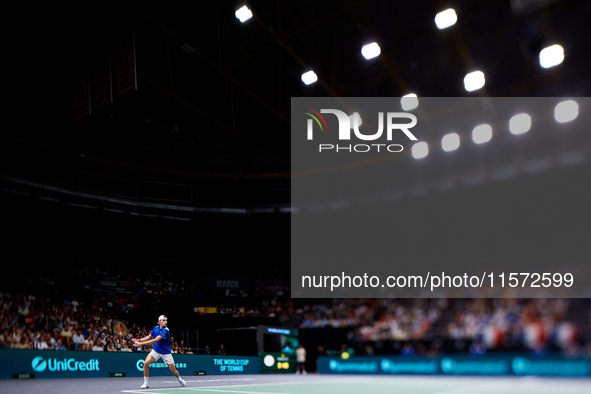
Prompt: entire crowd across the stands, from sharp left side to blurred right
<box><xmin>0</xmin><ymin>264</ymin><xmax>591</xmax><ymax>354</ymax></box>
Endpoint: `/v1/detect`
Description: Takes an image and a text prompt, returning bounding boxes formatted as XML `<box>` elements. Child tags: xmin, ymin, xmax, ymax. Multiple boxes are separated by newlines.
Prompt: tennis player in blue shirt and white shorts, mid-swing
<box><xmin>132</xmin><ymin>315</ymin><xmax>187</xmax><ymax>389</ymax></box>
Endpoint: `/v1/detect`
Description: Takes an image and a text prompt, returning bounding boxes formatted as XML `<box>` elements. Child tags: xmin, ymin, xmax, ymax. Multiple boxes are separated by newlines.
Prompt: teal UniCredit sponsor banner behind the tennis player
<box><xmin>0</xmin><ymin>349</ymin><xmax>261</xmax><ymax>379</ymax></box>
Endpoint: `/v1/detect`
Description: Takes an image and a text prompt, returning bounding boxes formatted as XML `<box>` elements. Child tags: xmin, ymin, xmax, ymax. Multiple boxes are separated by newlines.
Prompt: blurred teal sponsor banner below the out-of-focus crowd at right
<box><xmin>318</xmin><ymin>355</ymin><xmax>591</xmax><ymax>377</ymax></box>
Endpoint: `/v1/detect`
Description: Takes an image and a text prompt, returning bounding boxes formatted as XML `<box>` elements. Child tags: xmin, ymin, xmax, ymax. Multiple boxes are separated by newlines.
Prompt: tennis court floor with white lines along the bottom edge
<box><xmin>0</xmin><ymin>375</ymin><xmax>591</xmax><ymax>394</ymax></box>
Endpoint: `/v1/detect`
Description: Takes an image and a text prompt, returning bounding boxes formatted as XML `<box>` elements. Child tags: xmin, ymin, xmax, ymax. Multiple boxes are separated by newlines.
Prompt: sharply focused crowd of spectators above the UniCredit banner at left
<box><xmin>0</xmin><ymin>293</ymin><xmax>215</xmax><ymax>354</ymax></box>
